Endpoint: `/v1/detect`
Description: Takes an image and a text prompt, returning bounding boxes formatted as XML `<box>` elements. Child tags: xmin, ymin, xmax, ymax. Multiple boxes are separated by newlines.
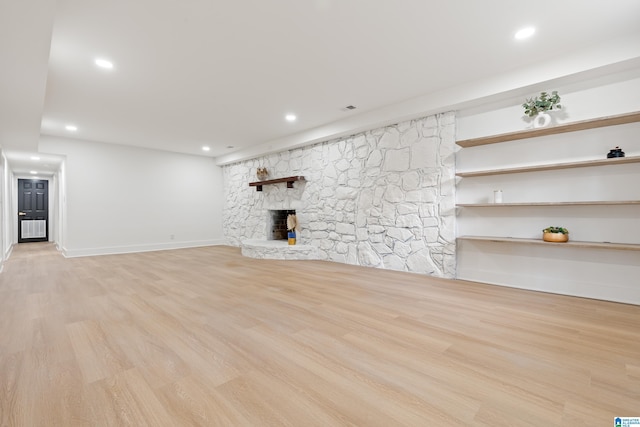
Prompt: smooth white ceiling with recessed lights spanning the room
<box><xmin>0</xmin><ymin>0</ymin><xmax>640</xmax><ymax>172</ymax></box>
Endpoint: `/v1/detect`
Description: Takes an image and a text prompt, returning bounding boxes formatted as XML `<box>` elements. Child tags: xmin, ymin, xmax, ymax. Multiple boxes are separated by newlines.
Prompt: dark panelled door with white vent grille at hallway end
<box><xmin>18</xmin><ymin>179</ymin><xmax>49</xmax><ymax>243</ymax></box>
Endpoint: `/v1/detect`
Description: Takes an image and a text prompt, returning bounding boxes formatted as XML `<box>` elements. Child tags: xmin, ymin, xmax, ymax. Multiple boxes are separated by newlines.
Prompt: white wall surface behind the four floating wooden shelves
<box><xmin>456</xmin><ymin>70</ymin><xmax>640</xmax><ymax>304</ymax></box>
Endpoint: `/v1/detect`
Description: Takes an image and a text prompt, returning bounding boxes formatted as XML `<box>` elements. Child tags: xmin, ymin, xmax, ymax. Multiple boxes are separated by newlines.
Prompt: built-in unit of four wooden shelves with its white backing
<box><xmin>456</xmin><ymin>112</ymin><xmax>640</xmax><ymax>304</ymax></box>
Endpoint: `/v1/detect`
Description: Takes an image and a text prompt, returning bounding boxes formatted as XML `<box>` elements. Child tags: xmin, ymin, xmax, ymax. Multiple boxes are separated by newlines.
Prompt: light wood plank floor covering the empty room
<box><xmin>0</xmin><ymin>244</ymin><xmax>640</xmax><ymax>427</ymax></box>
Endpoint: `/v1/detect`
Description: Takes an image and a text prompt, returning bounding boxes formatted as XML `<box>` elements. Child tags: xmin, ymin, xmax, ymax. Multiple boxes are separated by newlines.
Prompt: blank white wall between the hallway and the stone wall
<box><xmin>39</xmin><ymin>137</ymin><xmax>223</xmax><ymax>256</ymax></box>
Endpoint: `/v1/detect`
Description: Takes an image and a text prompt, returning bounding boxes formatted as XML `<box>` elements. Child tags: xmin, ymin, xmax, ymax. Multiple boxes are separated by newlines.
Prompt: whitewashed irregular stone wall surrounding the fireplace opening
<box><xmin>223</xmin><ymin>113</ymin><xmax>456</xmax><ymax>278</ymax></box>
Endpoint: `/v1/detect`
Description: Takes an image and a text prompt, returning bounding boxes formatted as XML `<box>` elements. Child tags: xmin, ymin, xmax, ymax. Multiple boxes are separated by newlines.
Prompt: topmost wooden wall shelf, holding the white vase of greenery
<box><xmin>456</xmin><ymin>111</ymin><xmax>640</xmax><ymax>148</ymax></box>
